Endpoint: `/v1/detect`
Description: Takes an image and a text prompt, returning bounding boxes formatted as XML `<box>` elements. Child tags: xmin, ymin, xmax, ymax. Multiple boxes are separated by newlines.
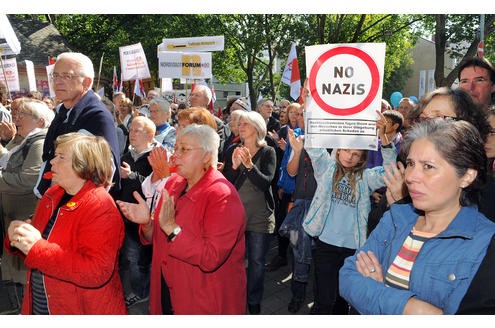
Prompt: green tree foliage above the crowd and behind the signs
<box><xmin>14</xmin><ymin>14</ymin><xmax>495</xmax><ymax>102</ymax></box>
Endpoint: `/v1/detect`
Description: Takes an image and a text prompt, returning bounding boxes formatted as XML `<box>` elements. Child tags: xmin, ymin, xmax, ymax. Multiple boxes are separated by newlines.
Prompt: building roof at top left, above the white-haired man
<box><xmin>9</xmin><ymin>15</ymin><xmax>70</xmax><ymax>66</ymax></box>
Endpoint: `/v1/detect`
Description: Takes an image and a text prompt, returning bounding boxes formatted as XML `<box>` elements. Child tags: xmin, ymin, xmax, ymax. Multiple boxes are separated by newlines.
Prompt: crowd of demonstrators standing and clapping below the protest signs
<box><xmin>0</xmin><ymin>53</ymin><xmax>495</xmax><ymax>315</ymax></box>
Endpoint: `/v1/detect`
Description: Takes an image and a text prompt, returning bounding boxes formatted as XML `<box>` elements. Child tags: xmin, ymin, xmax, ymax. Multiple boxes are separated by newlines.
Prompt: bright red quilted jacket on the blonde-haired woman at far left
<box><xmin>5</xmin><ymin>181</ymin><xmax>127</xmax><ymax>314</ymax></box>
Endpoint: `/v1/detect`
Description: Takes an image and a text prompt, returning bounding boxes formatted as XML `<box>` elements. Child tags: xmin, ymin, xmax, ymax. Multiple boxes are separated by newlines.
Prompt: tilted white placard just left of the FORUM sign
<box><xmin>119</xmin><ymin>43</ymin><xmax>151</xmax><ymax>81</ymax></box>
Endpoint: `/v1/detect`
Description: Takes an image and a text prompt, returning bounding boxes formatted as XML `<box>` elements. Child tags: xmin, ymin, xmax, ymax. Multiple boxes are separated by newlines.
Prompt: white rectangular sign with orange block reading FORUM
<box><xmin>158</xmin><ymin>51</ymin><xmax>212</xmax><ymax>79</ymax></box>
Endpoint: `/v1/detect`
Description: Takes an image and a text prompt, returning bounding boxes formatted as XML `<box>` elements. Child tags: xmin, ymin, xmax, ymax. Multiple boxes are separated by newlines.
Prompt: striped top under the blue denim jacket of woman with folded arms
<box><xmin>385</xmin><ymin>227</ymin><xmax>436</xmax><ymax>290</ymax></box>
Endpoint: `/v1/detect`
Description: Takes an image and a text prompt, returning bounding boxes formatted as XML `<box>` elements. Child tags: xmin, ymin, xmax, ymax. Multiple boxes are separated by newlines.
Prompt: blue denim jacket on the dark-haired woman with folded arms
<box><xmin>339</xmin><ymin>204</ymin><xmax>495</xmax><ymax>314</ymax></box>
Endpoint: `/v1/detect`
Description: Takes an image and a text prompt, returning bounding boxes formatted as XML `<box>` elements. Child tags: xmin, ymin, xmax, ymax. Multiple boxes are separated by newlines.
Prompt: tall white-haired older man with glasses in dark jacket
<box><xmin>34</xmin><ymin>52</ymin><xmax>120</xmax><ymax>198</ymax></box>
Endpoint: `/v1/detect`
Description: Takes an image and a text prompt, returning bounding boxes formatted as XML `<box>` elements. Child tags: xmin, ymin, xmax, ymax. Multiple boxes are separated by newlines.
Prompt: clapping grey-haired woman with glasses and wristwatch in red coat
<box><xmin>117</xmin><ymin>124</ymin><xmax>246</xmax><ymax>314</ymax></box>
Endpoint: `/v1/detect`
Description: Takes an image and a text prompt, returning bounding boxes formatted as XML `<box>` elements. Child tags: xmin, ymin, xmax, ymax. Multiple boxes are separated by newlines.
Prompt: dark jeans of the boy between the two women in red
<box><xmin>121</xmin><ymin>234</ymin><xmax>152</xmax><ymax>298</ymax></box>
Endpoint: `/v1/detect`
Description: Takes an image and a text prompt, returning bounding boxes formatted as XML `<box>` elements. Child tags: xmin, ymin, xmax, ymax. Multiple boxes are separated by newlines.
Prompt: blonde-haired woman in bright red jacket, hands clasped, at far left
<box><xmin>5</xmin><ymin>133</ymin><xmax>127</xmax><ymax>314</ymax></box>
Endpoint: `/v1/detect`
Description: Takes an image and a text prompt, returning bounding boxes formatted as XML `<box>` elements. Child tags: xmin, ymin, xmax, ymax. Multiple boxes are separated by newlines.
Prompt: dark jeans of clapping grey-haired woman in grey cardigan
<box><xmin>246</xmin><ymin>231</ymin><xmax>272</xmax><ymax>305</ymax></box>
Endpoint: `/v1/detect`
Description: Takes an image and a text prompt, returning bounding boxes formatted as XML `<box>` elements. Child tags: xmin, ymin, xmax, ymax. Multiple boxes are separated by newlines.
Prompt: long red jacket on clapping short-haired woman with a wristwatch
<box><xmin>142</xmin><ymin>168</ymin><xmax>246</xmax><ymax>314</ymax></box>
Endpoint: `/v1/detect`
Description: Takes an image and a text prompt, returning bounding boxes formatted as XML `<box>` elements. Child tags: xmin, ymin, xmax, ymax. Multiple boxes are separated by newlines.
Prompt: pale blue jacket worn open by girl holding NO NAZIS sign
<box><xmin>303</xmin><ymin>144</ymin><xmax>397</xmax><ymax>248</ymax></box>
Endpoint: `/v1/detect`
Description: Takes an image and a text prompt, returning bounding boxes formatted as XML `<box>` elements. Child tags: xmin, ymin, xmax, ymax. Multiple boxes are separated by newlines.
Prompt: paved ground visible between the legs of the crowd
<box><xmin>0</xmin><ymin>239</ymin><xmax>312</xmax><ymax>315</ymax></box>
